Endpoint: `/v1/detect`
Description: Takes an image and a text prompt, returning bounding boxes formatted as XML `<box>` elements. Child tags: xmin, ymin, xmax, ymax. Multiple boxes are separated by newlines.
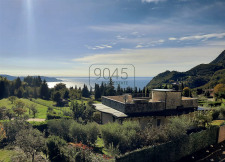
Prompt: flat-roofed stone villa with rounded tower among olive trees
<box><xmin>94</xmin><ymin>89</ymin><xmax>198</xmax><ymax>126</ymax></box>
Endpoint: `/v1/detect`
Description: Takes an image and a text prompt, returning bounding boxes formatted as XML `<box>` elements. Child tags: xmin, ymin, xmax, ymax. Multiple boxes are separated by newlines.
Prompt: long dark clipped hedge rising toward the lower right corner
<box><xmin>116</xmin><ymin>126</ymin><xmax>219</xmax><ymax>162</ymax></box>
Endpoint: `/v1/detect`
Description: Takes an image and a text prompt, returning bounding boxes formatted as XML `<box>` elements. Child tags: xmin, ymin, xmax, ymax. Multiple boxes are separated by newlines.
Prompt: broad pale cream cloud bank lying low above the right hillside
<box><xmin>73</xmin><ymin>45</ymin><xmax>224</xmax><ymax>76</ymax></box>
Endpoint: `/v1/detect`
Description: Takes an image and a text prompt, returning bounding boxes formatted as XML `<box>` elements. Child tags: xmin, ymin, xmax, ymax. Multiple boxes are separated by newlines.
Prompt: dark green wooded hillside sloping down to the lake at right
<box><xmin>147</xmin><ymin>50</ymin><xmax>225</xmax><ymax>88</ymax></box>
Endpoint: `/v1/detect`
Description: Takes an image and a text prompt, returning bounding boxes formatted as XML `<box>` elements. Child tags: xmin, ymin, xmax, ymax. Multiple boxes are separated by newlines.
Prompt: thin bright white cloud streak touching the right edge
<box><xmin>169</xmin><ymin>33</ymin><xmax>225</xmax><ymax>41</ymax></box>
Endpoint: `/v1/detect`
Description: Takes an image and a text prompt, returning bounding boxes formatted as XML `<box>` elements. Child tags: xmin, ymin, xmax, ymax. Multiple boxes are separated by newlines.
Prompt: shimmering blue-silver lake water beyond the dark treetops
<box><xmin>47</xmin><ymin>77</ymin><xmax>153</xmax><ymax>89</ymax></box>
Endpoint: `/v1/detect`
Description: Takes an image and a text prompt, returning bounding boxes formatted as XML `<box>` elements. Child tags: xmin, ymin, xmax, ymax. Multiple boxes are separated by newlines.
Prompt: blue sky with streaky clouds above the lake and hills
<box><xmin>0</xmin><ymin>0</ymin><xmax>225</xmax><ymax>77</ymax></box>
